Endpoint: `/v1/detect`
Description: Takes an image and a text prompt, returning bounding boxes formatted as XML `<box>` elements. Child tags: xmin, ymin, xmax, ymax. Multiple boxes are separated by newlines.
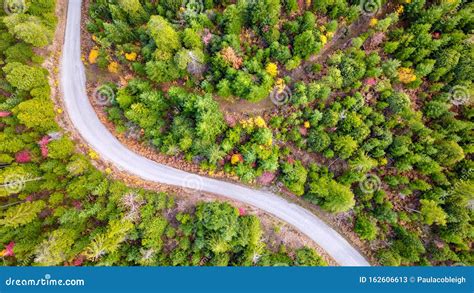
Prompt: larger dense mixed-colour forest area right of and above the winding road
<box><xmin>87</xmin><ymin>0</ymin><xmax>474</xmax><ymax>265</ymax></box>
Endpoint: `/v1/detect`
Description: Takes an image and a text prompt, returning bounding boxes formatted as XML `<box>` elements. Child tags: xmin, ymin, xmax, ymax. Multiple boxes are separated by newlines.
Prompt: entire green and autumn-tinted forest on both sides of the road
<box><xmin>0</xmin><ymin>0</ymin><xmax>474</xmax><ymax>266</ymax></box>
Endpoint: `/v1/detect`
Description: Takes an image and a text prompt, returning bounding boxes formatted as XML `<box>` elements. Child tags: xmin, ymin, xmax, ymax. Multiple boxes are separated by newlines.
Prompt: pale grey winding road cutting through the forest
<box><xmin>61</xmin><ymin>0</ymin><xmax>370</xmax><ymax>266</ymax></box>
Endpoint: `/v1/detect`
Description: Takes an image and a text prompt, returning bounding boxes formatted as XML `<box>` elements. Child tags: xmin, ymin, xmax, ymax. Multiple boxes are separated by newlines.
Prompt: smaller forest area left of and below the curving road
<box><xmin>0</xmin><ymin>0</ymin><xmax>326</xmax><ymax>266</ymax></box>
